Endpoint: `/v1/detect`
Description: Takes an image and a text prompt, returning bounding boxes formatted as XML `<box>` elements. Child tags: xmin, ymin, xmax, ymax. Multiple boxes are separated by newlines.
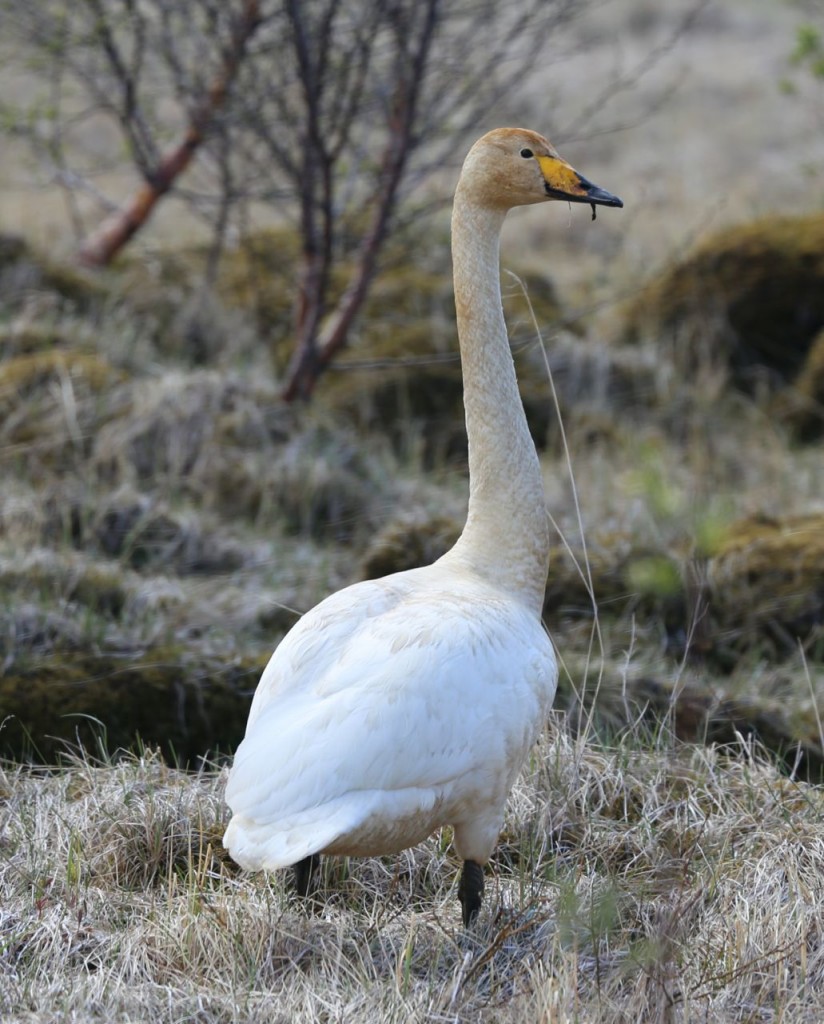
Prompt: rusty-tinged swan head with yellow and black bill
<box><xmin>461</xmin><ymin>128</ymin><xmax>623</xmax><ymax>218</ymax></box>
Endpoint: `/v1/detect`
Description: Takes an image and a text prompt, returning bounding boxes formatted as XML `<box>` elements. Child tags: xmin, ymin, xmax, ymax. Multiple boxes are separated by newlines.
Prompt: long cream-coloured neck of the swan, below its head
<box><xmin>440</xmin><ymin>183</ymin><xmax>549</xmax><ymax>612</ymax></box>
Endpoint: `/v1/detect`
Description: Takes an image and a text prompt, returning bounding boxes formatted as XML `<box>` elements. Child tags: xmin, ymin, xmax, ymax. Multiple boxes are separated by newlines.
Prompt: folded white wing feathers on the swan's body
<box><xmin>226</xmin><ymin>591</ymin><xmax>555</xmax><ymax>867</ymax></box>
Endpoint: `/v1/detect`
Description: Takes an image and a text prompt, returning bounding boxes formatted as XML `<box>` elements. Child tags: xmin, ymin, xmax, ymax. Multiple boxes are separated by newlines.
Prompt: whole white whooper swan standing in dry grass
<box><xmin>224</xmin><ymin>128</ymin><xmax>623</xmax><ymax>925</ymax></box>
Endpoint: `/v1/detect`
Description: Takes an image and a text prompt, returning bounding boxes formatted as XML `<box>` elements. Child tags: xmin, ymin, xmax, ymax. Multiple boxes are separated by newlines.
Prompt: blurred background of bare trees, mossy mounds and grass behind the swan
<box><xmin>0</xmin><ymin>0</ymin><xmax>824</xmax><ymax>778</ymax></box>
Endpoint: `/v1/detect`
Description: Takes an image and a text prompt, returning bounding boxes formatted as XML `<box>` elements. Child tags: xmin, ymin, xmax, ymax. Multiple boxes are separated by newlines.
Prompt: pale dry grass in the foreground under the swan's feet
<box><xmin>0</xmin><ymin>730</ymin><xmax>824</xmax><ymax>1024</ymax></box>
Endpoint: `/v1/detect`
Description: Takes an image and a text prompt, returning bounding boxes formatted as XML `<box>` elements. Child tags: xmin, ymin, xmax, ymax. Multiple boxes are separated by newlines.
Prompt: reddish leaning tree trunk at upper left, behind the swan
<box><xmin>77</xmin><ymin>0</ymin><xmax>261</xmax><ymax>266</ymax></box>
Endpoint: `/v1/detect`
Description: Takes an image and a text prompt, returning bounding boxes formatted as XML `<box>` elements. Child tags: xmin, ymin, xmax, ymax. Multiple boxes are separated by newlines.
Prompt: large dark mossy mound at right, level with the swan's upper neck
<box><xmin>624</xmin><ymin>213</ymin><xmax>824</xmax><ymax>392</ymax></box>
